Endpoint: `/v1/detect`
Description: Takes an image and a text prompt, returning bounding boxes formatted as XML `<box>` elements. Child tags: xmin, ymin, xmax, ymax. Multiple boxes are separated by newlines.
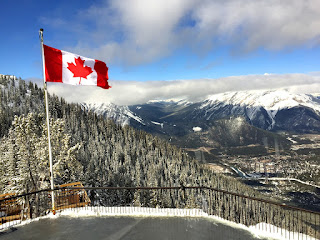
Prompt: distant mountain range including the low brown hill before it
<box><xmin>82</xmin><ymin>90</ymin><xmax>320</xmax><ymax>151</ymax></box>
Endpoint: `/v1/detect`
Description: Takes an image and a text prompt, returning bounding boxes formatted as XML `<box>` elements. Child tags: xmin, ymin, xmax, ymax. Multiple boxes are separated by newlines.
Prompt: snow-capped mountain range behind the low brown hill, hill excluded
<box><xmin>84</xmin><ymin>90</ymin><xmax>320</xmax><ymax>142</ymax></box>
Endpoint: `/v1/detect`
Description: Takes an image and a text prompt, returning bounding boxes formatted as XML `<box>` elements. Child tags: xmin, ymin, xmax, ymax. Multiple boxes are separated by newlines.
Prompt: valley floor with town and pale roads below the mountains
<box><xmin>185</xmin><ymin>134</ymin><xmax>320</xmax><ymax>211</ymax></box>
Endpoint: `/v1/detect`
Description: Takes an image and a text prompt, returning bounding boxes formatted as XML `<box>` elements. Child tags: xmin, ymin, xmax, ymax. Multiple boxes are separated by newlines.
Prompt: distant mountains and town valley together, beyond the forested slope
<box><xmin>81</xmin><ymin>90</ymin><xmax>320</xmax><ymax>211</ymax></box>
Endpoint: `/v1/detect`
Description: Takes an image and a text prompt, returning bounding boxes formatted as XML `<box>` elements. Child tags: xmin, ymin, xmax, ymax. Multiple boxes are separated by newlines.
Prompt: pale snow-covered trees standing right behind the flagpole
<box><xmin>0</xmin><ymin>113</ymin><xmax>82</xmax><ymax>193</ymax></box>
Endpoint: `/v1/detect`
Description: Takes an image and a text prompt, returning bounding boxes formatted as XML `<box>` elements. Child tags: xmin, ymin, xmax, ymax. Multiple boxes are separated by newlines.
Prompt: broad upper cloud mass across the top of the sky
<box><xmin>42</xmin><ymin>0</ymin><xmax>320</xmax><ymax>66</ymax></box>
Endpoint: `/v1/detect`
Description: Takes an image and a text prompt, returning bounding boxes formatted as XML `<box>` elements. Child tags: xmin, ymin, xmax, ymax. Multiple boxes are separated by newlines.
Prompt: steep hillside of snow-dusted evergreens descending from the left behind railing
<box><xmin>0</xmin><ymin>74</ymin><xmax>260</xmax><ymax>204</ymax></box>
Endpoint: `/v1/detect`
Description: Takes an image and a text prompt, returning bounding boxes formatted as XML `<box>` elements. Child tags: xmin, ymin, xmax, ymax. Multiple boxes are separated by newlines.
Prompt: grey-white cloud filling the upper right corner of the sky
<box><xmin>193</xmin><ymin>0</ymin><xmax>320</xmax><ymax>51</ymax></box>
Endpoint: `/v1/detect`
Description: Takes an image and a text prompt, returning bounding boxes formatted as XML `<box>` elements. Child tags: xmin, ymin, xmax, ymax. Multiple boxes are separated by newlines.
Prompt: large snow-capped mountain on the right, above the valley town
<box><xmin>192</xmin><ymin>90</ymin><xmax>320</xmax><ymax>131</ymax></box>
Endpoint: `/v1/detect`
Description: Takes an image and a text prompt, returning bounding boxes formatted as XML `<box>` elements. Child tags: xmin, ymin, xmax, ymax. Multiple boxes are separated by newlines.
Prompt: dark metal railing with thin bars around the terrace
<box><xmin>0</xmin><ymin>186</ymin><xmax>320</xmax><ymax>239</ymax></box>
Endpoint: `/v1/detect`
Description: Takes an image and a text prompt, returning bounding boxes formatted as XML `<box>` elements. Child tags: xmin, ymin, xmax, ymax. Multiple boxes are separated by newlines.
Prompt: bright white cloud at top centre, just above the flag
<box><xmin>76</xmin><ymin>0</ymin><xmax>192</xmax><ymax>65</ymax></box>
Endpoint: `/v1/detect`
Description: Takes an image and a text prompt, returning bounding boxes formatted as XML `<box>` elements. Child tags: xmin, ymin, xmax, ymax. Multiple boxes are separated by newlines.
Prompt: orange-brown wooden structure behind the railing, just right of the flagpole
<box><xmin>56</xmin><ymin>182</ymin><xmax>91</xmax><ymax>210</ymax></box>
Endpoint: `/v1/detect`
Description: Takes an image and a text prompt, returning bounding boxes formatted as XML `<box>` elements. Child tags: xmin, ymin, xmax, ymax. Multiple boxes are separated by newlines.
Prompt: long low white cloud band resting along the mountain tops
<box><xmin>44</xmin><ymin>74</ymin><xmax>320</xmax><ymax>105</ymax></box>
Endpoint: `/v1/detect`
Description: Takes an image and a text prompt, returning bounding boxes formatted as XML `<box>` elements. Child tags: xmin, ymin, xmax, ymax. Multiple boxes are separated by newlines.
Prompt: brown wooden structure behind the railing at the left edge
<box><xmin>0</xmin><ymin>193</ymin><xmax>22</xmax><ymax>224</ymax></box>
